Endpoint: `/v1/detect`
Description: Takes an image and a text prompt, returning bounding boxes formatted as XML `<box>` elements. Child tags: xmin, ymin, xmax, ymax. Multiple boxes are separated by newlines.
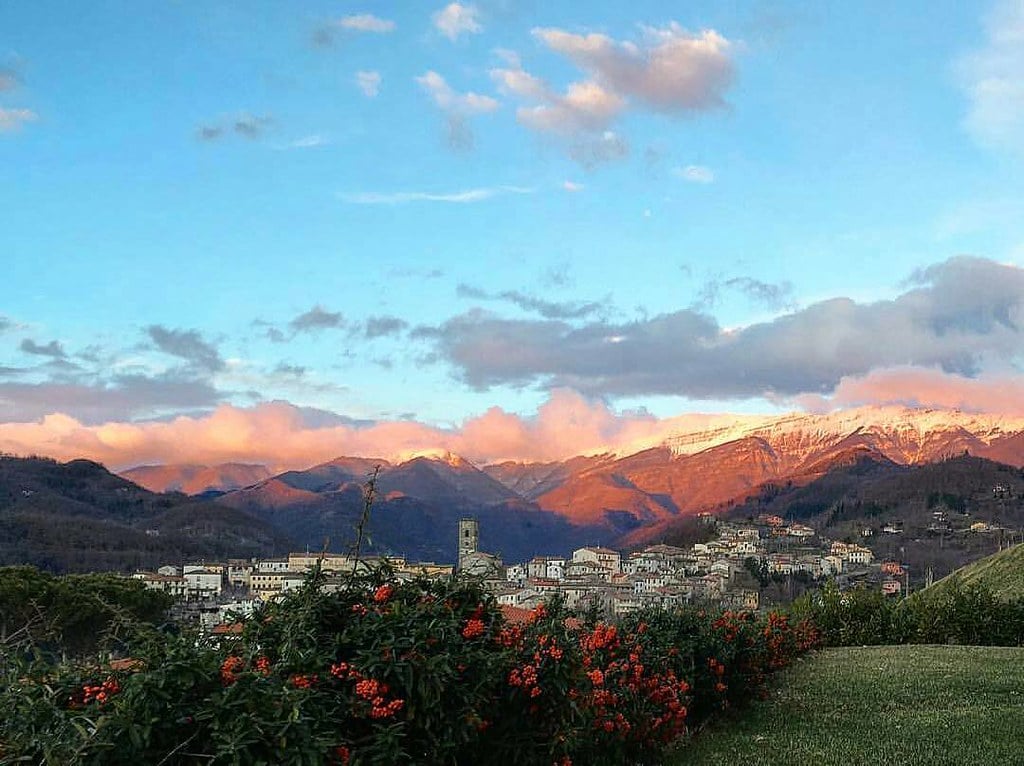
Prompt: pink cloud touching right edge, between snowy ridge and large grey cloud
<box><xmin>795</xmin><ymin>367</ymin><xmax>1024</xmax><ymax>416</ymax></box>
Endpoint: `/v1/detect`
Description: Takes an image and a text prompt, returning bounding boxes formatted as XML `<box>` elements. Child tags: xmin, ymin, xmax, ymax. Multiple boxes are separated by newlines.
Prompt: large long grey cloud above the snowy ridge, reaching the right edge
<box><xmin>420</xmin><ymin>257</ymin><xmax>1024</xmax><ymax>398</ymax></box>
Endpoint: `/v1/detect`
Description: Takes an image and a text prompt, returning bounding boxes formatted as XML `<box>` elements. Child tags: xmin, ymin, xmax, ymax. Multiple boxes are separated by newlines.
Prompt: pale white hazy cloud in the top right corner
<box><xmin>955</xmin><ymin>0</ymin><xmax>1024</xmax><ymax>152</ymax></box>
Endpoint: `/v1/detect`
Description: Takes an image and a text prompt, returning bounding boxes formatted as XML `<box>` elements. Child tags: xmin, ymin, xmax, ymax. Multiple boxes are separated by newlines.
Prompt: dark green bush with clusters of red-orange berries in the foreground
<box><xmin>0</xmin><ymin>571</ymin><xmax>815</xmax><ymax>766</ymax></box>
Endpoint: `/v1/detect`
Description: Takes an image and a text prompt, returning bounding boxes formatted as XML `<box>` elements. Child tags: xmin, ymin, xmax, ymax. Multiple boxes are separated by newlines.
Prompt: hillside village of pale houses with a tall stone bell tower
<box><xmin>133</xmin><ymin>514</ymin><xmax>937</xmax><ymax>629</ymax></box>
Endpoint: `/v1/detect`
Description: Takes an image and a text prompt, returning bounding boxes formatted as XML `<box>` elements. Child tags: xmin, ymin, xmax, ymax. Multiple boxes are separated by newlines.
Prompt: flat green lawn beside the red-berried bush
<box><xmin>667</xmin><ymin>646</ymin><xmax>1024</xmax><ymax>766</ymax></box>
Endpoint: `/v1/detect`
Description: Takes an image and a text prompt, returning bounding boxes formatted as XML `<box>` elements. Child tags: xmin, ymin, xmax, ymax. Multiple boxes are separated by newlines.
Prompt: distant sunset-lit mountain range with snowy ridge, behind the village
<box><xmin>123</xmin><ymin>407</ymin><xmax>1024</xmax><ymax>561</ymax></box>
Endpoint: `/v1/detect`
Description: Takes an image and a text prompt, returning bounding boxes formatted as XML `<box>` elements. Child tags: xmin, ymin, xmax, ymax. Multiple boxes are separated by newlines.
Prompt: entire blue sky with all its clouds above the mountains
<box><xmin>0</xmin><ymin>0</ymin><xmax>1024</xmax><ymax>467</ymax></box>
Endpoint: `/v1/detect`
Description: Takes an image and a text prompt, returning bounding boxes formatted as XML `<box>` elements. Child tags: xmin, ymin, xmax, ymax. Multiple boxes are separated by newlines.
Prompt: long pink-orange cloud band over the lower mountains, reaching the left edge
<box><xmin>0</xmin><ymin>390</ymin><xmax>735</xmax><ymax>470</ymax></box>
